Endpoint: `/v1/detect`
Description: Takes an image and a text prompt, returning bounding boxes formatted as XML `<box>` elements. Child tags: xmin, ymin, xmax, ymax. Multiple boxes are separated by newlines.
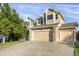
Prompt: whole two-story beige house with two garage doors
<box><xmin>29</xmin><ymin>8</ymin><xmax>78</xmax><ymax>44</ymax></box>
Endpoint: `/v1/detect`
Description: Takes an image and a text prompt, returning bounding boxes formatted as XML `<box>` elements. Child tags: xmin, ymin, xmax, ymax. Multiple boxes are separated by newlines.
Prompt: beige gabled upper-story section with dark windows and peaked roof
<box><xmin>44</xmin><ymin>8</ymin><xmax>64</xmax><ymax>24</ymax></box>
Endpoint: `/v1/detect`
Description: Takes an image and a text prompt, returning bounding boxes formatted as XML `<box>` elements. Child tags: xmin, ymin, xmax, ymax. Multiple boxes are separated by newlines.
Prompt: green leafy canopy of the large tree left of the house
<box><xmin>0</xmin><ymin>3</ymin><xmax>24</xmax><ymax>40</ymax></box>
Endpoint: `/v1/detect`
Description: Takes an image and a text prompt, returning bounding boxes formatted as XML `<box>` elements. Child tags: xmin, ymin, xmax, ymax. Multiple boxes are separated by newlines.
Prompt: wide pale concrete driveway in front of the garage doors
<box><xmin>0</xmin><ymin>41</ymin><xmax>74</xmax><ymax>56</ymax></box>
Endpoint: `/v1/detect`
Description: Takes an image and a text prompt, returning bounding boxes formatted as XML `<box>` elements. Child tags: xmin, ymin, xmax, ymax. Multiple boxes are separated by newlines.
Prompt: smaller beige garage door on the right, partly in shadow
<box><xmin>60</xmin><ymin>29</ymin><xmax>74</xmax><ymax>44</ymax></box>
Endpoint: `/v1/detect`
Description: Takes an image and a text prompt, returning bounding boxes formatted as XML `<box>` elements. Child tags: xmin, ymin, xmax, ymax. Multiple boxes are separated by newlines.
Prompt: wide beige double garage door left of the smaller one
<box><xmin>32</xmin><ymin>29</ymin><xmax>49</xmax><ymax>41</ymax></box>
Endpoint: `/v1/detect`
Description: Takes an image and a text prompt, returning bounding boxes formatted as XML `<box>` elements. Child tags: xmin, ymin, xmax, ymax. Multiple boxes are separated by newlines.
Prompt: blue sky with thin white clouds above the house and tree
<box><xmin>9</xmin><ymin>3</ymin><xmax>79</xmax><ymax>27</ymax></box>
